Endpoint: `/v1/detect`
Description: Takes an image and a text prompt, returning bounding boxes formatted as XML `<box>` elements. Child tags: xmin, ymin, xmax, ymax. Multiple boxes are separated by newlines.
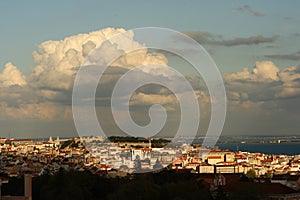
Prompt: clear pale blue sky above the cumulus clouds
<box><xmin>0</xmin><ymin>1</ymin><xmax>300</xmax><ymax>73</ymax></box>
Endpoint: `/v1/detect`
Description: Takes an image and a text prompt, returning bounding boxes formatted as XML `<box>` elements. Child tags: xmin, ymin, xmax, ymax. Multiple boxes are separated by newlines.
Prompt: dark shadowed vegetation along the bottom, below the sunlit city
<box><xmin>2</xmin><ymin>170</ymin><xmax>272</xmax><ymax>200</ymax></box>
